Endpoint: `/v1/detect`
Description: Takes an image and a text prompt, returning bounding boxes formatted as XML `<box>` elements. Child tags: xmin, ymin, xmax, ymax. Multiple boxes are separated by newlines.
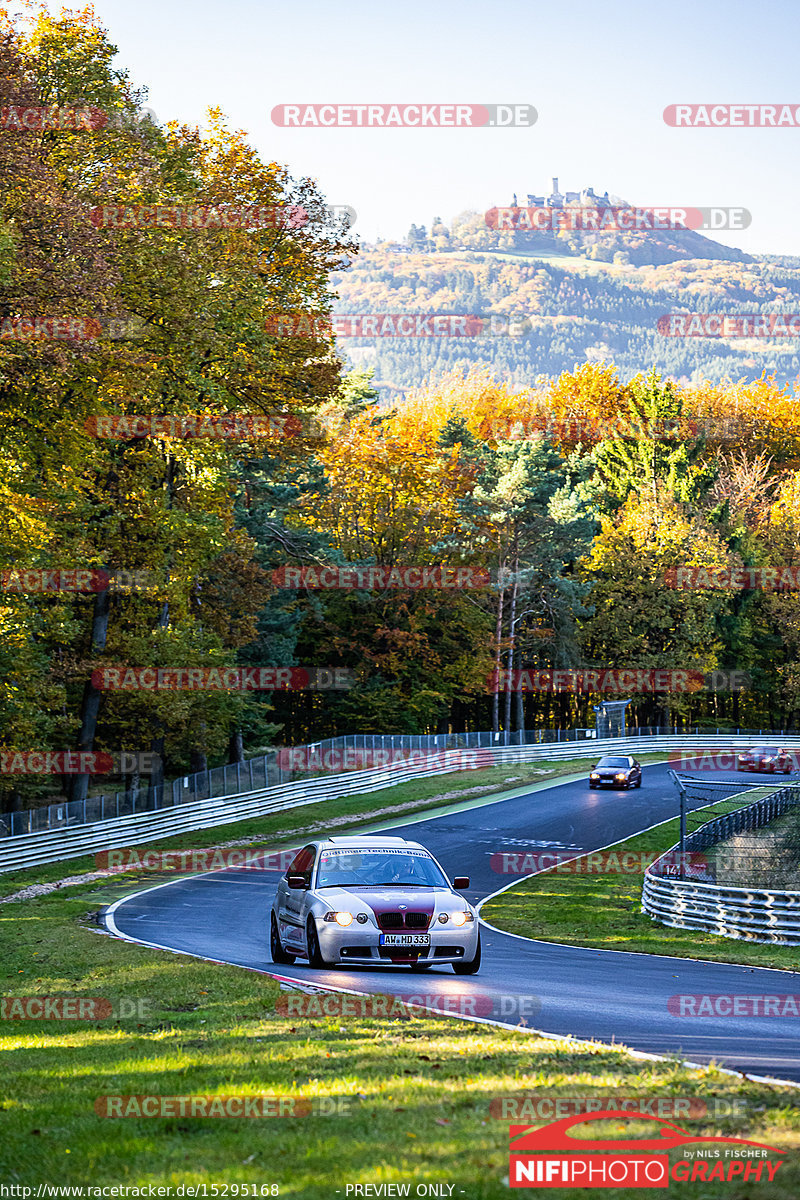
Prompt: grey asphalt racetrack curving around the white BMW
<box><xmin>106</xmin><ymin>764</ymin><xmax>800</xmax><ymax>1081</ymax></box>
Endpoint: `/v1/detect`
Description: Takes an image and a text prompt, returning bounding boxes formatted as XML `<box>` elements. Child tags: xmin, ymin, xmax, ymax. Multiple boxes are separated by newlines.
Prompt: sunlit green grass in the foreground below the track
<box><xmin>0</xmin><ymin>887</ymin><xmax>800</xmax><ymax>1200</ymax></box>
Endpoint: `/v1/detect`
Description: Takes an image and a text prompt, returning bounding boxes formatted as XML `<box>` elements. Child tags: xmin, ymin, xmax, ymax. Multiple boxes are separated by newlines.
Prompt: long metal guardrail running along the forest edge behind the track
<box><xmin>0</xmin><ymin>734</ymin><xmax>800</xmax><ymax>874</ymax></box>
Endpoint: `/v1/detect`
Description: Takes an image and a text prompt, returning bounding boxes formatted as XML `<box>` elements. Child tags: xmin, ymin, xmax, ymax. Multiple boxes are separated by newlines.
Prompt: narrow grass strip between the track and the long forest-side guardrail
<box><xmin>0</xmin><ymin>752</ymin><xmax>666</xmax><ymax>898</ymax></box>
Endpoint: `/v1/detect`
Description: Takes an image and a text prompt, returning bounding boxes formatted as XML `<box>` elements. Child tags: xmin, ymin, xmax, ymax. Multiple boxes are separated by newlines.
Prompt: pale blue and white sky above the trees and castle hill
<box><xmin>34</xmin><ymin>0</ymin><xmax>800</xmax><ymax>254</ymax></box>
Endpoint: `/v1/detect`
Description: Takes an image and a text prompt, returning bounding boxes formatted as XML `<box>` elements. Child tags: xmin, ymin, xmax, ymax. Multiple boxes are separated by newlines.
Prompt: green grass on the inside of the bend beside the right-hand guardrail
<box><xmin>481</xmin><ymin>788</ymin><xmax>800</xmax><ymax>971</ymax></box>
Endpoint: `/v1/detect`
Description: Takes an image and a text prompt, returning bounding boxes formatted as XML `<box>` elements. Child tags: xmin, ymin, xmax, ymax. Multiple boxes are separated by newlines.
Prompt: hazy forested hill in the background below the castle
<box><xmin>333</xmin><ymin>196</ymin><xmax>800</xmax><ymax>400</ymax></box>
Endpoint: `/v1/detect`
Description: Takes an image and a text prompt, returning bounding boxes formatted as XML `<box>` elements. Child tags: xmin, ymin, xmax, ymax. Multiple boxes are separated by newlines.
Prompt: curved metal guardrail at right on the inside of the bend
<box><xmin>642</xmin><ymin>784</ymin><xmax>800</xmax><ymax>946</ymax></box>
